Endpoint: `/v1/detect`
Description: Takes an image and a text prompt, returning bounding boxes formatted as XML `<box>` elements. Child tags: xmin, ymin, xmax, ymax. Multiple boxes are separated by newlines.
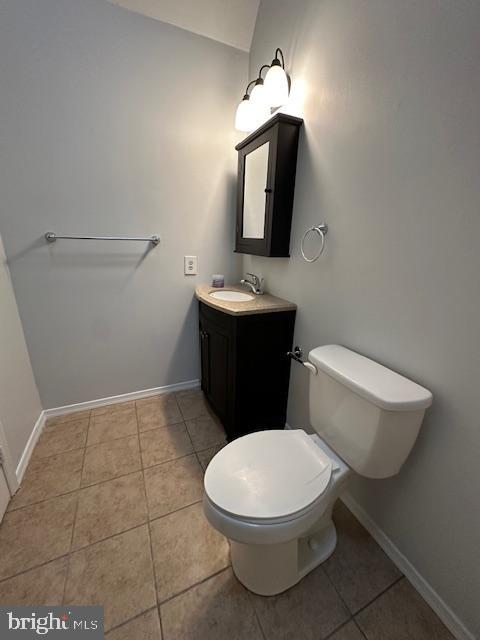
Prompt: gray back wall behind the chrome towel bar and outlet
<box><xmin>0</xmin><ymin>0</ymin><xmax>248</xmax><ymax>408</ymax></box>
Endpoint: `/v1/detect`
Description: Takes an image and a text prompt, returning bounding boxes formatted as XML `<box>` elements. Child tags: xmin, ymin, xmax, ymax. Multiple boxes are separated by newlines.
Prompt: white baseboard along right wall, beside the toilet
<box><xmin>341</xmin><ymin>492</ymin><xmax>475</xmax><ymax>640</ymax></box>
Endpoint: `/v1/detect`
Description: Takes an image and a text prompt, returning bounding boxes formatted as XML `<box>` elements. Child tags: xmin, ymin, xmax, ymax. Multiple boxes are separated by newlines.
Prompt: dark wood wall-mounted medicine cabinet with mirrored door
<box><xmin>235</xmin><ymin>113</ymin><xmax>303</xmax><ymax>257</ymax></box>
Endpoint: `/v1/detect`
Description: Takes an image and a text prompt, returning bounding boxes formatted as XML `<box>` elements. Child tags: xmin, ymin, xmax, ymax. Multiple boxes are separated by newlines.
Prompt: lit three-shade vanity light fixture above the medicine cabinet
<box><xmin>235</xmin><ymin>49</ymin><xmax>289</xmax><ymax>132</ymax></box>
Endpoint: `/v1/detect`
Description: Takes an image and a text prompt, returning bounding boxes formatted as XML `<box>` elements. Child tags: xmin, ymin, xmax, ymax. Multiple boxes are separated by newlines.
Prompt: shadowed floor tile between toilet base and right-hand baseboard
<box><xmin>322</xmin><ymin>501</ymin><xmax>402</xmax><ymax>613</ymax></box>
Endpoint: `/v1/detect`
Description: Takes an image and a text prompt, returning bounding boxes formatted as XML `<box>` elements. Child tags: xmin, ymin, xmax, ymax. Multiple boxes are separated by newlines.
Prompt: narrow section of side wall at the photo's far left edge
<box><xmin>0</xmin><ymin>238</ymin><xmax>42</xmax><ymax>467</ymax></box>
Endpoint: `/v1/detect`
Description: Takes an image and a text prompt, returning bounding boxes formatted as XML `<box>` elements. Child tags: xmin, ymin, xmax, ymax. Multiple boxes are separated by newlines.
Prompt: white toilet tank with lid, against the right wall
<box><xmin>308</xmin><ymin>344</ymin><xmax>432</xmax><ymax>478</ymax></box>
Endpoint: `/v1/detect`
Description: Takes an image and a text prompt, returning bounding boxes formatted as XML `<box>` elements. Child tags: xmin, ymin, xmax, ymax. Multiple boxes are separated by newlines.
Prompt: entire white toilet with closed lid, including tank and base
<box><xmin>203</xmin><ymin>345</ymin><xmax>432</xmax><ymax>596</ymax></box>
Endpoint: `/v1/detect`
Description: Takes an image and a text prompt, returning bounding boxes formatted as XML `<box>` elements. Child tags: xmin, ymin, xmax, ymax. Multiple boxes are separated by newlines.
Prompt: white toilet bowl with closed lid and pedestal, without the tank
<box><xmin>204</xmin><ymin>430</ymin><xmax>349</xmax><ymax>595</ymax></box>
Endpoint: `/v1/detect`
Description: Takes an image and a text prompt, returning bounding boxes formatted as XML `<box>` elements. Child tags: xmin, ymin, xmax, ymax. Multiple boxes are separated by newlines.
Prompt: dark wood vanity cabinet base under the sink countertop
<box><xmin>199</xmin><ymin>302</ymin><xmax>295</xmax><ymax>440</ymax></box>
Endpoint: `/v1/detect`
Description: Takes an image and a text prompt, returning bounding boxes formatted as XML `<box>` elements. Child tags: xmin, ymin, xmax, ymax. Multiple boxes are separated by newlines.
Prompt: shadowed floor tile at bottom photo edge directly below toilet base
<box><xmin>252</xmin><ymin>567</ymin><xmax>350</xmax><ymax>640</ymax></box>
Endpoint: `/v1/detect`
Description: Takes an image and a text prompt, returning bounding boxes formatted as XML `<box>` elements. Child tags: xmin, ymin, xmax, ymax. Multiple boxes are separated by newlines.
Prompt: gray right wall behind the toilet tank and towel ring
<box><xmin>248</xmin><ymin>0</ymin><xmax>480</xmax><ymax>636</ymax></box>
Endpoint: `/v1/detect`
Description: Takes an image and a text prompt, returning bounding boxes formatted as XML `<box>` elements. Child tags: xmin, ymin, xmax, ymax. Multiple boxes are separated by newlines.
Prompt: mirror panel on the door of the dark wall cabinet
<box><xmin>242</xmin><ymin>142</ymin><xmax>270</xmax><ymax>238</ymax></box>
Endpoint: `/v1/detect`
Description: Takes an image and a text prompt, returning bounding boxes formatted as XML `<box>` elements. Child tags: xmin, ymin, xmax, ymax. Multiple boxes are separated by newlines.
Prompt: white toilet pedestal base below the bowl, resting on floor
<box><xmin>230</xmin><ymin>517</ymin><xmax>337</xmax><ymax>596</ymax></box>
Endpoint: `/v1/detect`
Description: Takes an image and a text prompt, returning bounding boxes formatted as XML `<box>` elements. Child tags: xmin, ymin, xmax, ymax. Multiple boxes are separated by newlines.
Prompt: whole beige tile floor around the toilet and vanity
<box><xmin>0</xmin><ymin>391</ymin><xmax>452</xmax><ymax>640</ymax></box>
